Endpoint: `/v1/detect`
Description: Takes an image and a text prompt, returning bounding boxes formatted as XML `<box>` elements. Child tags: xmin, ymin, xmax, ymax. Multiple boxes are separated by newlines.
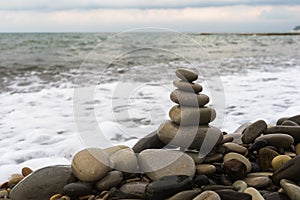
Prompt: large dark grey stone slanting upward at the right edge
<box><xmin>273</xmin><ymin>155</ymin><xmax>300</xmax><ymax>184</ymax></box>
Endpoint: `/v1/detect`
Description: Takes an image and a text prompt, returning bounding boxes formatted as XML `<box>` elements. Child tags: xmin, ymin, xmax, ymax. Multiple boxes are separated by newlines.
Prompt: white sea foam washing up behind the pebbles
<box><xmin>0</xmin><ymin>66</ymin><xmax>300</xmax><ymax>182</ymax></box>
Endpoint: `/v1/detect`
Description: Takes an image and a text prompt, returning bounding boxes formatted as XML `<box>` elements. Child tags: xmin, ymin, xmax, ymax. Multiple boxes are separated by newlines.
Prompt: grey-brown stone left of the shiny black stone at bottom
<box><xmin>120</xmin><ymin>182</ymin><xmax>148</xmax><ymax>199</ymax></box>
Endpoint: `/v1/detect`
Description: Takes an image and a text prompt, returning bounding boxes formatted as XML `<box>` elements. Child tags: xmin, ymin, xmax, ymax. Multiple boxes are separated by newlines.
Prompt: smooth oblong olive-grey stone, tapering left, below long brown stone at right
<box><xmin>257</xmin><ymin>133</ymin><xmax>294</xmax><ymax>148</ymax></box>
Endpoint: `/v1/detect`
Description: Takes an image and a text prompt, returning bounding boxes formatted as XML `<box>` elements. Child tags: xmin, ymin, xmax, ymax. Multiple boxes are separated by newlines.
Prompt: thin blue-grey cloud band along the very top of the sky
<box><xmin>0</xmin><ymin>0</ymin><xmax>300</xmax><ymax>10</ymax></box>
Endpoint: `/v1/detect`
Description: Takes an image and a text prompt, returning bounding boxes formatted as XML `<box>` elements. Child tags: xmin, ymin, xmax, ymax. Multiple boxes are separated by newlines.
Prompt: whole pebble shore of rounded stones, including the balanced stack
<box><xmin>0</xmin><ymin>69</ymin><xmax>300</xmax><ymax>200</ymax></box>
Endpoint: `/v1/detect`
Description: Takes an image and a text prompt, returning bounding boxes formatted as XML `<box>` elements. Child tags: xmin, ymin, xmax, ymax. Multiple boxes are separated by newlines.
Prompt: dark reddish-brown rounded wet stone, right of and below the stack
<box><xmin>222</xmin><ymin>159</ymin><xmax>247</xmax><ymax>181</ymax></box>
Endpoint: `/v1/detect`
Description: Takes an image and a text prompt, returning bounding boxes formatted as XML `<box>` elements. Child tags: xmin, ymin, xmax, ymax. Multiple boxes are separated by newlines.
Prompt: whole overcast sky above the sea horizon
<box><xmin>0</xmin><ymin>0</ymin><xmax>300</xmax><ymax>32</ymax></box>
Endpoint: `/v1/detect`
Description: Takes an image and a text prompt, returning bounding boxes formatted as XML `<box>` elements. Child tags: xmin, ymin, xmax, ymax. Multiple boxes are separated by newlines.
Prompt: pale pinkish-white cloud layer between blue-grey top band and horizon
<box><xmin>0</xmin><ymin>6</ymin><xmax>300</xmax><ymax>32</ymax></box>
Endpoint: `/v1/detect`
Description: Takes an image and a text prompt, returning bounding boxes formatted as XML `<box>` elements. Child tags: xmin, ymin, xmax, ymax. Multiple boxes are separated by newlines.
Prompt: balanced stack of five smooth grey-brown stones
<box><xmin>157</xmin><ymin>68</ymin><xmax>223</xmax><ymax>151</ymax></box>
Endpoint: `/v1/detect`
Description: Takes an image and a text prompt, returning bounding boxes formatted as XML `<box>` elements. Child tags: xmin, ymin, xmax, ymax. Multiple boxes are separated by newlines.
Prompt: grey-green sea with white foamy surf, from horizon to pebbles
<box><xmin>0</xmin><ymin>30</ymin><xmax>300</xmax><ymax>182</ymax></box>
